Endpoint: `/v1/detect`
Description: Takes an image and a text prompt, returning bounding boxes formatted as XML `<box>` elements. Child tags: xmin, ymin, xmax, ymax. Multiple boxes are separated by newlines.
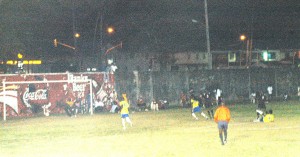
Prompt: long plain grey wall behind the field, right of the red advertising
<box><xmin>115</xmin><ymin>68</ymin><xmax>300</xmax><ymax>105</ymax></box>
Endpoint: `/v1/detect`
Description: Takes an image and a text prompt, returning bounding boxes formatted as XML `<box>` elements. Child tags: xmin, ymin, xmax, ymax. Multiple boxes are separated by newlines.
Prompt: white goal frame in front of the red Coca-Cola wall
<box><xmin>2</xmin><ymin>79</ymin><xmax>93</xmax><ymax>121</ymax></box>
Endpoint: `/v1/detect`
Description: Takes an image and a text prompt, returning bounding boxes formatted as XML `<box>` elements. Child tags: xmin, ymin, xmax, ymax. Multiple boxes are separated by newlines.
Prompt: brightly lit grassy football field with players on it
<box><xmin>0</xmin><ymin>101</ymin><xmax>300</xmax><ymax>157</ymax></box>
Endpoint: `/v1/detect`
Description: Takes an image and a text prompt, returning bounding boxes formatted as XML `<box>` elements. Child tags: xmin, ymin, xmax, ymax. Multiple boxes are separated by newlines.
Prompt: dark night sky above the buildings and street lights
<box><xmin>0</xmin><ymin>0</ymin><xmax>300</xmax><ymax>60</ymax></box>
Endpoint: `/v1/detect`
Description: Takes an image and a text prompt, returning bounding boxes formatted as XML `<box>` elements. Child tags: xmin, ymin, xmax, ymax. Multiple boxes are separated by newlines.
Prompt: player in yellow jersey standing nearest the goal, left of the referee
<box><xmin>119</xmin><ymin>96</ymin><xmax>132</xmax><ymax>130</ymax></box>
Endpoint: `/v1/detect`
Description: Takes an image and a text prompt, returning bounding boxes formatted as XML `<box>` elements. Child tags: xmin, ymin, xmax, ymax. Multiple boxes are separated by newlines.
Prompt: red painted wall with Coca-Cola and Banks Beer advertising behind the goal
<box><xmin>0</xmin><ymin>72</ymin><xmax>114</xmax><ymax>116</ymax></box>
